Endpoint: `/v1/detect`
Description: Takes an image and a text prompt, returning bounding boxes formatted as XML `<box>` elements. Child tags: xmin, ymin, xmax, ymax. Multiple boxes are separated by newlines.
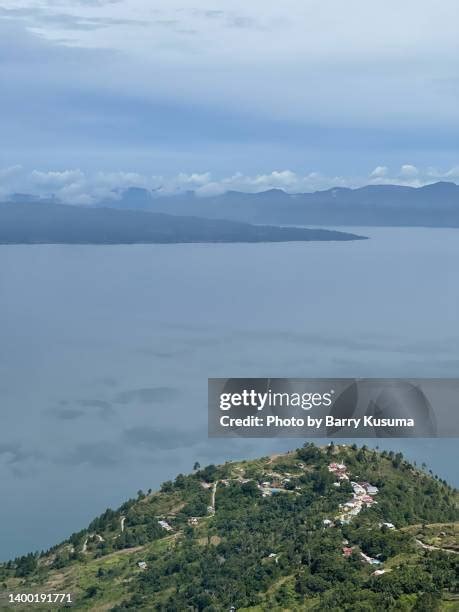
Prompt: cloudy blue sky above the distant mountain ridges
<box><xmin>0</xmin><ymin>0</ymin><xmax>459</xmax><ymax>204</ymax></box>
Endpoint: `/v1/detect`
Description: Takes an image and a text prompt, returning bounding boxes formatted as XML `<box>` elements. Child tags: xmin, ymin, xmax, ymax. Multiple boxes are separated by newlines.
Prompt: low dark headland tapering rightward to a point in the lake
<box><xmin>0</xmin><ymin>201</ymin><xmax>362</xmax><ymax>244</ymax></box>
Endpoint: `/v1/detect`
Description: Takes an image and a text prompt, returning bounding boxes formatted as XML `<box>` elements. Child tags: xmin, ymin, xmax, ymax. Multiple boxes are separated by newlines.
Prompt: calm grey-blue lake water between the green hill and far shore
<box><xmin>0</xmin><ymin>228</ymin><xmax>459</xmax><ymax>559</ymax></box>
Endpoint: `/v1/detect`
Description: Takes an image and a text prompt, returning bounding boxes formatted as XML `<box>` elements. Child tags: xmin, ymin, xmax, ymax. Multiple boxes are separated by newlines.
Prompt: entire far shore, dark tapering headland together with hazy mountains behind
<box><xmin>0</xmin><ymin>182</ymin><xmax>459</xmax><ymax>244</ymax></box>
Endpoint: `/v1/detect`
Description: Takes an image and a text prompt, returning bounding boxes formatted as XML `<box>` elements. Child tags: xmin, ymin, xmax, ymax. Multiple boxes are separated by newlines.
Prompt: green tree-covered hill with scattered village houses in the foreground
<box><xmin>0</xmin><ymin>444</ymin><xmax>459</xmax><ymax>612</ymax></box>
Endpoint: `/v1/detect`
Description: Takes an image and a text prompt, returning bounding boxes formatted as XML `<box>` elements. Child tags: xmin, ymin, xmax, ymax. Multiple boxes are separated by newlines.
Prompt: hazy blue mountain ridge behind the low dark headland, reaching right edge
<box><xmin>96</xmin><ymin>182</ymin><xmax>459</xmax><ymax>227</ymax></box>
